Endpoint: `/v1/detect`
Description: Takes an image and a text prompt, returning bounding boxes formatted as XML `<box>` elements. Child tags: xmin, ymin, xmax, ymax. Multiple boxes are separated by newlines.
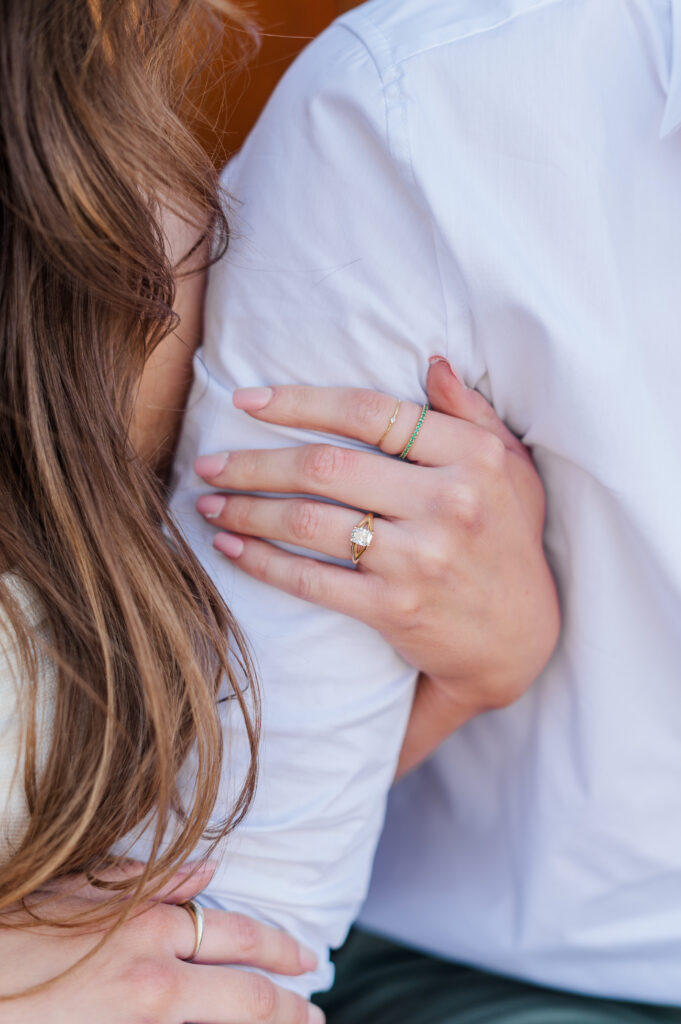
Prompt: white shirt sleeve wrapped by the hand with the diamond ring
<box><xmin>167</xmin><ymin>25</ymin><xmax>444</xmax><ymax>994</ymax></box>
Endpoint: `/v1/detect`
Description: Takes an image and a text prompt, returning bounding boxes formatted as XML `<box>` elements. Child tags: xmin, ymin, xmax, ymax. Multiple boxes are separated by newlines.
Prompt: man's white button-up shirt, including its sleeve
<box><xmin>173</xmin><ymin>0</ymin><xmax>681</xmax><ymax>1005</ymax></box>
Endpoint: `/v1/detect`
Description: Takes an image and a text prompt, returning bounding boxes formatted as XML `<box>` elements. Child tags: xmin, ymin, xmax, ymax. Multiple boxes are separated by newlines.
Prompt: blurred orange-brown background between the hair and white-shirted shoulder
<box><xmin>191</xmin><ymin>0</ymin><xmax>358</xmax><ymax>166</ymax></box>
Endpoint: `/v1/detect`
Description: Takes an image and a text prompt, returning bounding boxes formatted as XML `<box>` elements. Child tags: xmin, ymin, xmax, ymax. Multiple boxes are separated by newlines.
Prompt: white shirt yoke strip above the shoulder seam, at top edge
<box><xmin>337</xmin><ymin>0</ymin><xmax>570</xmax><ymax>65</ymax></box>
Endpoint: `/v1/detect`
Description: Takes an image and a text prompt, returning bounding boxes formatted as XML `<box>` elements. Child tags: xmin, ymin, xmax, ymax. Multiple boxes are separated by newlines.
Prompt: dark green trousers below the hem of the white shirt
<box><xmin>315</xmin><ymin>929</ymin><xmax>681</xmax><ymax>1024</ymax></box>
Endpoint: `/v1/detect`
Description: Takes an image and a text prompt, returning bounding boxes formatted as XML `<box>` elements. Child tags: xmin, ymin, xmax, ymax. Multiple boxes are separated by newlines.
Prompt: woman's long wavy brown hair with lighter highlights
<box><xmin>0</xmin><ymin>0</ymin><xmax>258</xmax><ymax>920</ymax></box>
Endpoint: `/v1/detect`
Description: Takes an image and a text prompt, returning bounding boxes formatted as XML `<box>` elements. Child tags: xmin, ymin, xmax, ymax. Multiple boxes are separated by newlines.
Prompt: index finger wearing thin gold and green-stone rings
<box><xmin>233</xmin><ymin>385</ymin><xmax>481</xmax><ymax>466</ymax></box>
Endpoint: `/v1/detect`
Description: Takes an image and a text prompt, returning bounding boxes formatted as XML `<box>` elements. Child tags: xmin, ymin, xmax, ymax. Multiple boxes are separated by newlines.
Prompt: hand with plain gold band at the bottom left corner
<box><xmin>0</xmin><ymin>869</ymin><xmax>324</xmax><ymax>1024</ymax></box>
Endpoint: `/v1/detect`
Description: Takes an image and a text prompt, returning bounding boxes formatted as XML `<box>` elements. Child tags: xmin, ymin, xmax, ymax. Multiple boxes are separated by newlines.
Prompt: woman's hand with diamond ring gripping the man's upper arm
<box><xmin>196</xmin><ymin>358</ymin><xmax>559</xmax><ymax>770</ymax></box>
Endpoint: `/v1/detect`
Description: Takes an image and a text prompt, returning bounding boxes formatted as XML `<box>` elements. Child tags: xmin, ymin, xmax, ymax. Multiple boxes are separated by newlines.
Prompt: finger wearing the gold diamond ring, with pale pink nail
<box><xmin>197</xmin><ymin>495</ymin><xmax>398</xmax><ymax>570</ymax></box>
